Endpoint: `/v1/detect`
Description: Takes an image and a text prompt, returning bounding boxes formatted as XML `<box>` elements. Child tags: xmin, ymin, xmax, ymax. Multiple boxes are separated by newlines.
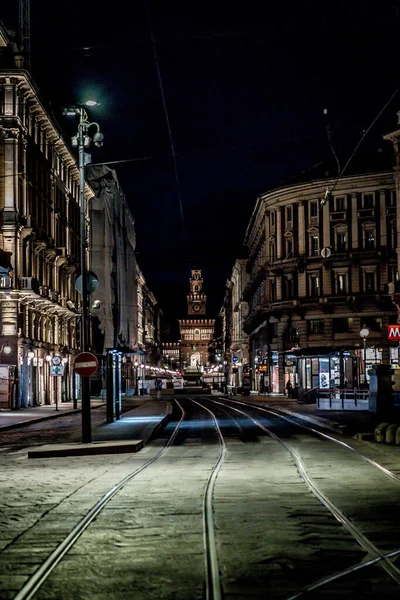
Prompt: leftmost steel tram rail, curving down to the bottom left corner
<box><xmin>14</xmin><ymin>400</ymin><xmax>185</xmax><ymax>600</ymax></box>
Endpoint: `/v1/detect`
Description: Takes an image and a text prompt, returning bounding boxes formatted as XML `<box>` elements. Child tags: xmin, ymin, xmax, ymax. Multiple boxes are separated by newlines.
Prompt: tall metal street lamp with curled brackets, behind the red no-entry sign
<box><xmin>63</xmin><ymin>103</ymin><xmax>104</xmax><ymax>444</ymax></box>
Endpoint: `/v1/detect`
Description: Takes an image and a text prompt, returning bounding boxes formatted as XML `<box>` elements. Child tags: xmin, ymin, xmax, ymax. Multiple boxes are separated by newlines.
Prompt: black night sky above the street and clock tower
<box><xmin>0</xmin><ymin>0</ymin><xmax>400</xmax><ymax>338</ymax></box>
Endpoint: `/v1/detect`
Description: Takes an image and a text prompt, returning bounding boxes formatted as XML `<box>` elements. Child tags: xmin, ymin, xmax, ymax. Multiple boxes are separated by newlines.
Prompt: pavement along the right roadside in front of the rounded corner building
<box><xmin>234</xmin><ymin>394</ymin><xmax>380</xmax><ymax>436</ymax></box>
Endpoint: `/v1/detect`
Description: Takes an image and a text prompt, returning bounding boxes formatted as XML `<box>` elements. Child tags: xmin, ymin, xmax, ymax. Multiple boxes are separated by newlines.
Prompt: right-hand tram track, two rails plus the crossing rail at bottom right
<box><xmin>202</xmin><ymin>399</ymin><xmax>400</xmax><ymax>600</ymax></box>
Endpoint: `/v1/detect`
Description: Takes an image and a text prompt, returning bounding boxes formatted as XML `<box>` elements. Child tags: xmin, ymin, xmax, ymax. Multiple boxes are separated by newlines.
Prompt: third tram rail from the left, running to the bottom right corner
<box><xmin>209</xmin><ymin>400</ymin><xmax>400</xmax><ymax>585</ymax></box>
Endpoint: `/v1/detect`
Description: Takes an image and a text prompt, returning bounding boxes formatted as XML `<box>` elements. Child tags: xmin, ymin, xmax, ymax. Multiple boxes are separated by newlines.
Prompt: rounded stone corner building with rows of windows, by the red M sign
<box><xmin>243</xmin><ymin>158</ymin><xmax>399</xmax><ymax>395</ymax></box>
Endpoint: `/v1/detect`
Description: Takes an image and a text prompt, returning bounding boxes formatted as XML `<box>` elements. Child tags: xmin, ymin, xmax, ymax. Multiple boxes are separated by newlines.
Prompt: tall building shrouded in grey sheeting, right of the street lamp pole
<box><xmin>86</xmin><ymin>165</ymin><xmax>161</xmax><ymax>392</ymax></box>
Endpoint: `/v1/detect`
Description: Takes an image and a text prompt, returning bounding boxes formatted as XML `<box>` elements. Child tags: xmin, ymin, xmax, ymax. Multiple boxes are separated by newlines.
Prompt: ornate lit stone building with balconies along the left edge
<box><xmin>0</xmin><ymin>24</ymin><xmax>94</xmax><ymax>408</ymax></box>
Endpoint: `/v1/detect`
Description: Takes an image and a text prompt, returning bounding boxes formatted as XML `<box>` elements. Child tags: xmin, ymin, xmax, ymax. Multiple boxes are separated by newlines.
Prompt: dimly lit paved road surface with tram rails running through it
<box><xmin>0</xmin><ymin>397</ymin><xmax>400</xmax><ymax>600</ymax></box>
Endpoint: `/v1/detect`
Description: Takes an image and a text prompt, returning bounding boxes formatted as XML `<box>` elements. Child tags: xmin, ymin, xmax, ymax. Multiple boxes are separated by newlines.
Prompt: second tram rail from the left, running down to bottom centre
<box><xmin>191</xmin><ymin>398</ymin><xmax>228</xmax><ymax>600</ymax></box>
